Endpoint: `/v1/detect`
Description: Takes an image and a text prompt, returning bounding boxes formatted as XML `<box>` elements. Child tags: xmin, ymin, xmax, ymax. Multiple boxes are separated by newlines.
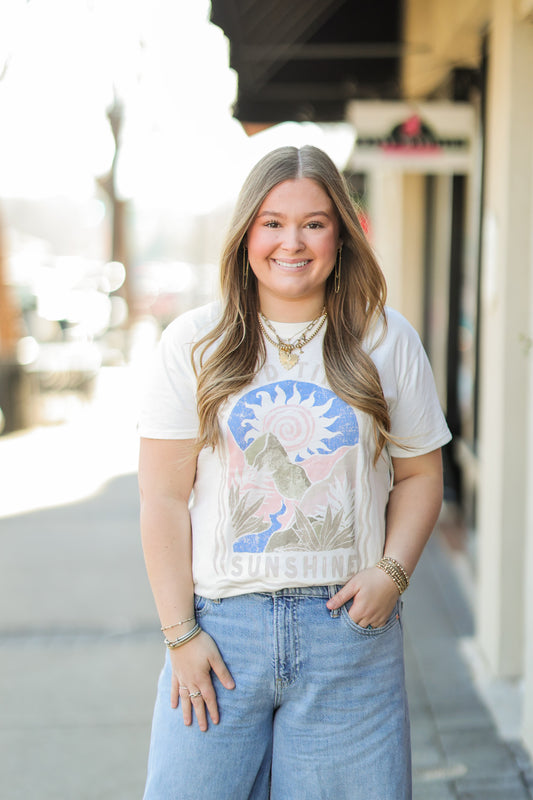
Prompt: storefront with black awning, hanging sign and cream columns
<box><xmin>212</xmin><ymin>0</ymin><xmax>533</xmax><ymax>753</ymax></box>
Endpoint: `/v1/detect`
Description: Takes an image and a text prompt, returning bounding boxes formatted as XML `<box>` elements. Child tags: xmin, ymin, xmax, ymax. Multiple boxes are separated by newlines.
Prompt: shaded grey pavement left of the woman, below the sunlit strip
<box><xmin>0</xmin><ymin>475</ymin><xmax>164</xmax><ymax>800</ymax></box>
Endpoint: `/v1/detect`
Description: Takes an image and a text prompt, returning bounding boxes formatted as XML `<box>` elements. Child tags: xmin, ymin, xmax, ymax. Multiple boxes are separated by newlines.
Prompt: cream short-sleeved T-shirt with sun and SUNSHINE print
<box><xmin>139</xmin><ymin>303</ymin><xmax>451</xmax><ymax>598</ymax></box>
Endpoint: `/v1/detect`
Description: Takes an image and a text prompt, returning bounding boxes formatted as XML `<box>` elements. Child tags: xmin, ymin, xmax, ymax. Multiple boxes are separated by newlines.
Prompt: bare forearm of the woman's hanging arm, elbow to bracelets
<box><xmin>141</xmin><ymin>497</ymin><xmax>194</xmax><ymax>638</ymax></box>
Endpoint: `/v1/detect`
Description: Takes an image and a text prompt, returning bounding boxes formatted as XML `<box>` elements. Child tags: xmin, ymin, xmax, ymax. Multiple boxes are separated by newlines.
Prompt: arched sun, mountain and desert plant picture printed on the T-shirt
<box><xmin>228</xmin><ymin>380</ymin><xmax>359</xmax><ymax>553</ymax></box>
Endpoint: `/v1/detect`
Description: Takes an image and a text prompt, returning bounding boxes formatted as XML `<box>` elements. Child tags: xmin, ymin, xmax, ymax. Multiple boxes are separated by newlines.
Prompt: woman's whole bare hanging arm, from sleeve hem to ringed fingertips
<box><xmin>139</xmin><ymin>438</ymin><xmax>235</xmax><ymax>731</ymax></box>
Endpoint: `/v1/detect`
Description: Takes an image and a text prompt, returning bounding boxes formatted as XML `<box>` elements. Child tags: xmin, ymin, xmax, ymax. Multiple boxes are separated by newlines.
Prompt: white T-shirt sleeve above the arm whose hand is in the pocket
<box><xmin>372</xmin><ymin>310</ymin><xmax>451</xmax><ymax>458</ymax></box>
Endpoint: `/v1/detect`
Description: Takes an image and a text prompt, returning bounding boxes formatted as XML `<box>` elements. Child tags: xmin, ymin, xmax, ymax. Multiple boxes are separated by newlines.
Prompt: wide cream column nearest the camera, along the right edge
<box><xmin>478</xmin><ymin>0</ymin><xmax>533</xmax><ymax>677</ymax></box>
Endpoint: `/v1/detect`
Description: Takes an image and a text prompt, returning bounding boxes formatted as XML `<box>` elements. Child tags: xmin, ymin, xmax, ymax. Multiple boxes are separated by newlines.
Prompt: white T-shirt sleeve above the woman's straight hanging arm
<box><xmin>137</xmin><ymin>315</ymin><xmax>202</xmax><ymax>439</ymax></box>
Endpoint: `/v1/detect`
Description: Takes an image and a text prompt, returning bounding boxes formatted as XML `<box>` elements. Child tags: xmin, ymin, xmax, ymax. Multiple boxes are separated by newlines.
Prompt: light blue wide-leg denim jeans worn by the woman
<box><xmin>144</xmin><ymin>586</ymin><xmax>411</xmax><ymax>800</ymax></box>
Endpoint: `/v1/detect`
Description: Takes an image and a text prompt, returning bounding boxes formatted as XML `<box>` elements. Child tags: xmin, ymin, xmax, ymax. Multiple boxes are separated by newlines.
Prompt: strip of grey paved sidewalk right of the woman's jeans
<box><xmin>405</xmin><ymin>528</ymin><xmax>533</xmax><ymax>800</ymax></box>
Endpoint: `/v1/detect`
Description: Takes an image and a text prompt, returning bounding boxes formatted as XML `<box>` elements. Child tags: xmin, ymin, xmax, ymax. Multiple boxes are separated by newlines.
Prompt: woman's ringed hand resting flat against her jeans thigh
<box><xmin>170</xmin><ymin>631</ymin><xmax>235</xmax><ymax>731</ymax></box>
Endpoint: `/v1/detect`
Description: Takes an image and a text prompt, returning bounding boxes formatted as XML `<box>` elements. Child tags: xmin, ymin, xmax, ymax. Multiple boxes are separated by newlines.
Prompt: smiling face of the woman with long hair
<box><xmin>247</xmin><ymin>178</ymin><xmax>341</xmax><ymax>322</ymax></box>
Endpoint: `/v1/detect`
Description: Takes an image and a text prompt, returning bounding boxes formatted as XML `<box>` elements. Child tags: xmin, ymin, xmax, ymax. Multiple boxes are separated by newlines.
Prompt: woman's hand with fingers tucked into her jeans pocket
<box><xmin>327</xmin><ymin>567</ymin><xmax>399</xmax><ymax>628</ymax></box>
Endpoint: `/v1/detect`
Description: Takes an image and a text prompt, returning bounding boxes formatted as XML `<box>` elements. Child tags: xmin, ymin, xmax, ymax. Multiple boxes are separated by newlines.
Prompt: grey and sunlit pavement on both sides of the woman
<box><xmin>0</xmin><ymin>368</ymin><xmax>533</xmax><ymax>800</ymax></box>
